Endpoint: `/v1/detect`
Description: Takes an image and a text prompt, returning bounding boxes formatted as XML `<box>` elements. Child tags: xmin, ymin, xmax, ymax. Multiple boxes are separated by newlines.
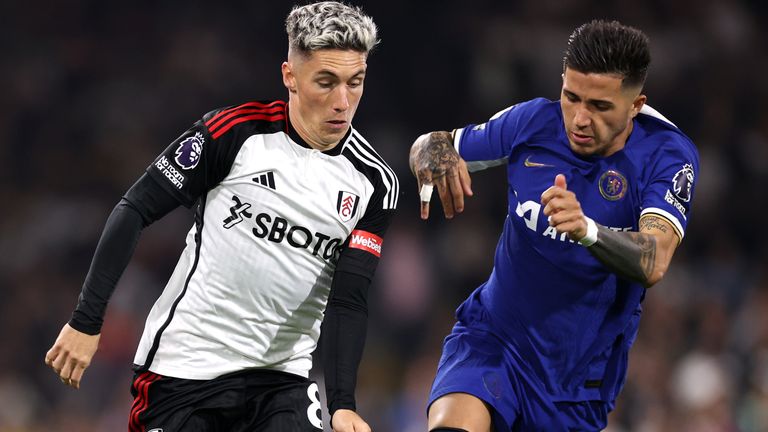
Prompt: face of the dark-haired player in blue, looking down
<box><xmin>560</xmin><ymin>68</ymin><xmax>646</xmax><ymax>157</ymax></box>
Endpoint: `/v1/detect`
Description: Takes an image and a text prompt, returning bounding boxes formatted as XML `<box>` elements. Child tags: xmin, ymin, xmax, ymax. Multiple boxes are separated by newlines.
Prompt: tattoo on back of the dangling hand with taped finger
<box><xmin>410</xmin><ymin>132</ymin><xmax>460</xmax><ymax>184</ymax></box>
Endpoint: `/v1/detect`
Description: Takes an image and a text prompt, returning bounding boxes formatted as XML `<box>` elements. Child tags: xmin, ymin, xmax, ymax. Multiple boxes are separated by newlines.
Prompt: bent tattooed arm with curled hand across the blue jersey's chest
<box><xmin>542</xmin><ymin>175</ymin><xmax>680</xmax><ymax>288</ymax></box>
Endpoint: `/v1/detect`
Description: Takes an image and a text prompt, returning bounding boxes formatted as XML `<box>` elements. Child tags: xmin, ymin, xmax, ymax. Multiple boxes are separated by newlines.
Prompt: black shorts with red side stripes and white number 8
<box><xmin>128</xmin><ymin>370</ymin><xmax>323</xmax><ymax>432</ymax></box>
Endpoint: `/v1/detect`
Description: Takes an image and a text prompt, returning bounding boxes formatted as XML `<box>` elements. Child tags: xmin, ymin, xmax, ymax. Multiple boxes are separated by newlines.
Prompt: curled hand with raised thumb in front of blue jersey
<box><xmin>541</xmin><ymin>174</ymin><xmax>587</xmax><ymax>241</ymax></box>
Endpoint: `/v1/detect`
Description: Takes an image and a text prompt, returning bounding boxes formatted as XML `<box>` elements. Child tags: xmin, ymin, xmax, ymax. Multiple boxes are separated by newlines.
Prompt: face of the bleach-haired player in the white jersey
<box><xmin>282</xmin><ymin>49</ymin><xmax>367</xmax><ymax>150</ymax></box>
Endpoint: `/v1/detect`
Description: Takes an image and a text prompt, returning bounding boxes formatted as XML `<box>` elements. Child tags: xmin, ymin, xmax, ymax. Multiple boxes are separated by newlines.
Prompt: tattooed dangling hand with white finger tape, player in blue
<box><xmin>409</xmin><ymin>132</ymin><xmax>472</xmax><ymax>220</ymax></box>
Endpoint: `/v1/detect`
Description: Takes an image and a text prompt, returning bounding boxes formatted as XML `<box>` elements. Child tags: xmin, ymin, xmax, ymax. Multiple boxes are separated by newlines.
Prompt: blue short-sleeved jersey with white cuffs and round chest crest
<box><xmin>454</xmin><ymin>99</ymin><xmax>699</xmax><ymax>402</ymax></box>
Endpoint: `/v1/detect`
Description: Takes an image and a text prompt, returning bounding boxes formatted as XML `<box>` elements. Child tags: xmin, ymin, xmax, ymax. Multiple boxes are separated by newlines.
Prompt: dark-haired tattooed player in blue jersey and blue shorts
<box><xmin>410</xmin><ymin>21</ymin><xmax>699</xmax><ymax>432</ymax></box>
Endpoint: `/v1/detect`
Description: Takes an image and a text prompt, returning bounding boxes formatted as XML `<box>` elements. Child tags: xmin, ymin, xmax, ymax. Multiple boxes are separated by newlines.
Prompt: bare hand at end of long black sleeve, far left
<box><xmin>45</xmin><ymin>324</ymin><xmax>101</xmax><ymax>389</ymax></box>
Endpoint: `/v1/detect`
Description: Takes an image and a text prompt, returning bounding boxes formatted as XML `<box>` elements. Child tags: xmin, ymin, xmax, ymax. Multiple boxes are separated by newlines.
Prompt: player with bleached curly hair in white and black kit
<box><xmin>46</xmin><ymin>2</ymin><xmax>400</xmax><ymax>432</ymax></box>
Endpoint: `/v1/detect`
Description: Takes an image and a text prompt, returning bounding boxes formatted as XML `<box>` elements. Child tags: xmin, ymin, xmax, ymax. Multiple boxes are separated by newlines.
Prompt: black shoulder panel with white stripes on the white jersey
<box><xmin>340</xmin><ymin>127</ymin><xmax>400</xmax><ymax>208</ymax></box>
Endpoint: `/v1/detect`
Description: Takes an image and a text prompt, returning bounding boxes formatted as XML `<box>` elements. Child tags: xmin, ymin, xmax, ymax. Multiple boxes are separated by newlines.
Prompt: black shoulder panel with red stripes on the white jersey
<box><xmin>202</xmin><ymin>100</ymin><xmax>287</xmax><ymax>140</ymax></box>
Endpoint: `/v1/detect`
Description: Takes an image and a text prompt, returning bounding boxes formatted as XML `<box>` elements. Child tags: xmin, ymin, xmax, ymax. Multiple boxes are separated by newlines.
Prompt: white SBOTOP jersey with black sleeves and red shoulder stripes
<box><xmin>135</xmin><ymin>101</ymin><xmax>399</xmax><ymax>379</ymax></box>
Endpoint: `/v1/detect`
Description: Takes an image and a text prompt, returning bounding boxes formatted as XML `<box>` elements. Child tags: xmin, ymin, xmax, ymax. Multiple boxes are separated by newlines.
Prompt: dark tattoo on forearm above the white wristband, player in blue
<box><xmin>589</xmin><ymin>226</ymin><xmax>666</xmax><ymax>287</ymax></box>
